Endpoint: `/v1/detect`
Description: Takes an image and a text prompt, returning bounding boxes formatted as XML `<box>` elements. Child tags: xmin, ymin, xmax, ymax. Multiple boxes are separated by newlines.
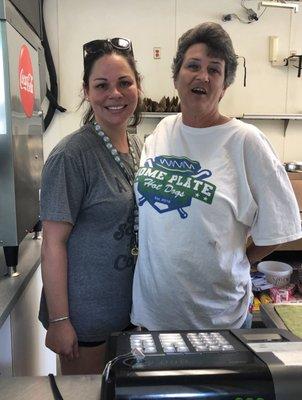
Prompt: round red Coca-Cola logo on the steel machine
<box><xmin>19</xmin><ymin>44</ymin><xmax>35</xmax><ymax>118</ymax></box>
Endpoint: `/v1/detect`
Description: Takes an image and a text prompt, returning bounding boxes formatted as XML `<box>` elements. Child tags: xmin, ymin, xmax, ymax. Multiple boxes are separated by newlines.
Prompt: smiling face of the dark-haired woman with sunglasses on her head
<box><xmin>84</xmin><ymin>53</ymin><xmax>139</xmax><ymax>132</ymax></box>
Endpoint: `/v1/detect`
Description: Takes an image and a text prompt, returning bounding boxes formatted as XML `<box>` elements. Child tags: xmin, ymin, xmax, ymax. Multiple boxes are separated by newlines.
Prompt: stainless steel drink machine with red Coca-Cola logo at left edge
<box><xmin>0</xmin><ymin>0</ymin><xmax>46</xmax><ymax>272</ymax></box>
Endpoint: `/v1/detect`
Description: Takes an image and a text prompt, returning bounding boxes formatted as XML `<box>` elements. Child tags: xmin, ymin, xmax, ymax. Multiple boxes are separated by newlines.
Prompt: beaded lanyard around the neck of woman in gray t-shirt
<box><xmin>93</xmin><ymin>121</ymin><xmax>138</xmax><ymax>256</ymax></box>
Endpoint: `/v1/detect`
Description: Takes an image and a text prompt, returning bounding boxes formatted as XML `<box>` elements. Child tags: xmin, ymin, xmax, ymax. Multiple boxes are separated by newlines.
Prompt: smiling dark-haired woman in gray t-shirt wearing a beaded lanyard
<box><xmin>39</xmin><ymin>38</ymin><xmax>141</xmax><ymax>374</ymax></box>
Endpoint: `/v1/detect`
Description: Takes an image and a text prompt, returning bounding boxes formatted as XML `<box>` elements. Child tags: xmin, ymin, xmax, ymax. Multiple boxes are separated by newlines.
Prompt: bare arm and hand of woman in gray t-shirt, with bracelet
<box><xmin>42</xmin><ymin>220</ymin><xmax>78</xmax><ymax>360</ymax></box>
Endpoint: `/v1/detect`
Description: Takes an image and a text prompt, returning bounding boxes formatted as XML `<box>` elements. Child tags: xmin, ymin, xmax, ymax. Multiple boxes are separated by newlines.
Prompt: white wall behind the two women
<box><xmin>44</xmin><ymin>0</ymin><xmax>302</xmax><ymax>161</ymax></box>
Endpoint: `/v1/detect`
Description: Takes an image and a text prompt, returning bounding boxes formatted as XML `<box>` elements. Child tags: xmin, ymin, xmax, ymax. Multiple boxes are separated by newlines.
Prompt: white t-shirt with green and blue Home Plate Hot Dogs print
<box><xmin>132</xmin><ymin>114</ymin><xmax>302</xmax><ymax>330</ymax></box>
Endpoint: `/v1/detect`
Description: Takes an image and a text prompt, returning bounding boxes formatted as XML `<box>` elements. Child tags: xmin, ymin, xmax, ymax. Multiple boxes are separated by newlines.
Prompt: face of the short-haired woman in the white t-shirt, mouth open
<box><xmin>174</xmin><ymin>43</ymin><xmax>226</xmax><ymax>123</ymax></box>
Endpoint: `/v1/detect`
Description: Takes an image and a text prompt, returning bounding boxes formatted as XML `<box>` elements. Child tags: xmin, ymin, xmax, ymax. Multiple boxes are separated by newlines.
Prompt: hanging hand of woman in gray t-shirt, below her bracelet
<box><xmin>45</xmin><ymin>320</ymin><xmax>79</xmax><ymax>361</ymax></box>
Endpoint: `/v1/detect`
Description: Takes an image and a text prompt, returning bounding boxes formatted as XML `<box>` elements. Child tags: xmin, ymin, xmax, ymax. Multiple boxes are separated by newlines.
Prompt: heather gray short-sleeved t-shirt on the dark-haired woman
<box><xmin>39</xmin><ymin>124</ymin><xmax>141</xmax><ymax>342</ymax></box>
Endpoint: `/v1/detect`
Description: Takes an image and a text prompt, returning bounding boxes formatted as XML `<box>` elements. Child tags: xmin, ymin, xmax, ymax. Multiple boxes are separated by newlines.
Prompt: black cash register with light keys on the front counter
<box><xmin>101</xmin><ymin>329</ymin><xmax>302</xmax><ymax>400</ymax></box>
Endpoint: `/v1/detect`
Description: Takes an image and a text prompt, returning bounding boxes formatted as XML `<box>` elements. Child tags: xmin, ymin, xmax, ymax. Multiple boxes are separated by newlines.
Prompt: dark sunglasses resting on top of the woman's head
<box><xmin>83</xmin><ymin>38</ymin><xmax>133</xmax><ymax>59</ymax></box>
